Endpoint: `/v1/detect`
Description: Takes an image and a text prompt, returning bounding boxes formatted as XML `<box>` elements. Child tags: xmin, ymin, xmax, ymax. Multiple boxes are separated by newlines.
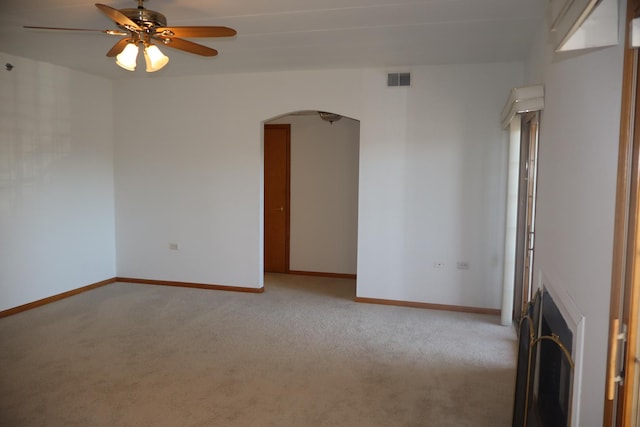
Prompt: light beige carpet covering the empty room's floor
<box><xmin>0</xmin><ymin>274</ymin><xmax>516</xmax><ymax>427</ymax></box>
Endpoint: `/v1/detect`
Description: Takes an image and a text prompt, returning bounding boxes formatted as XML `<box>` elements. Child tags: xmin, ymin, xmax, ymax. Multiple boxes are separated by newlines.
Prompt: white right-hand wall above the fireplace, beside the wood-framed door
<box><xmin>527</xmin><ymin>13</ymin><xmax>624</xmax><ymax>426</ymax></box>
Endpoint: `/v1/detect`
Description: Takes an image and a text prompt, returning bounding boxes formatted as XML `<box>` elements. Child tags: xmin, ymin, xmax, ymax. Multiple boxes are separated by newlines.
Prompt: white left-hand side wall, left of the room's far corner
<box><xmin>0</xmin><ymin>53</ymin><xmax>115</xmax><ymax>310</ymax></box>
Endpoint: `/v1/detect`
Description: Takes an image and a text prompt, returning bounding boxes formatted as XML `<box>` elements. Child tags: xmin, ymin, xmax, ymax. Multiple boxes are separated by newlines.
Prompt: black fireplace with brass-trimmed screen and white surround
<box><xmin>513</xmin><ymin>275</ymin><xmax>584</xmax><ymax>427</ymax></box>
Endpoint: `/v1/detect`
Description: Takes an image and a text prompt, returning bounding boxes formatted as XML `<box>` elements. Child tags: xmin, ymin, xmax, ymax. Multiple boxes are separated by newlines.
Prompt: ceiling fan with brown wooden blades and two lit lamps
<box><xmin>24</xmin><ymin>0</ymin><xmax>236</xmax><ymax>72</ymax></box>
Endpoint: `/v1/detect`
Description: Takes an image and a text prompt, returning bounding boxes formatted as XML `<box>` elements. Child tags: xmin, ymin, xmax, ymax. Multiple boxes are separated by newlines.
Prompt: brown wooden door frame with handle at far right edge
<box><xmin>603</xmin><ymin>0</ymin><xmax>640</xmax><ymax>427</ymax></box>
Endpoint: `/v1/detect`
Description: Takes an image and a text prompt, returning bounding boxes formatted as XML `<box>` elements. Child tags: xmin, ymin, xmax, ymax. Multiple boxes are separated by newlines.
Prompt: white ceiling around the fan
<box><xmin>0</xmin><ymin>0</ymin><xmax>547</xmax><ymax>78</ymax></box>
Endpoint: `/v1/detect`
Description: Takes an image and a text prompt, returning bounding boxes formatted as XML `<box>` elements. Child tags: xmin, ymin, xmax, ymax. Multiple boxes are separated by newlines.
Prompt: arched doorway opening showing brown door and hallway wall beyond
<box><xmin>263</xmin><ymin>110</ymin><xmax>360</xmax><ymax>284</ymax></box>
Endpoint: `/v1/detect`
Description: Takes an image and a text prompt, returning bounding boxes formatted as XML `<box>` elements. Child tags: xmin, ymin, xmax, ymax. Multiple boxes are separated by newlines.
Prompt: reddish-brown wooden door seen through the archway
<box><xmin>264</xmin><ymin>125</ymin><xmax>291</xmax><ymax>273</ymax></box>
